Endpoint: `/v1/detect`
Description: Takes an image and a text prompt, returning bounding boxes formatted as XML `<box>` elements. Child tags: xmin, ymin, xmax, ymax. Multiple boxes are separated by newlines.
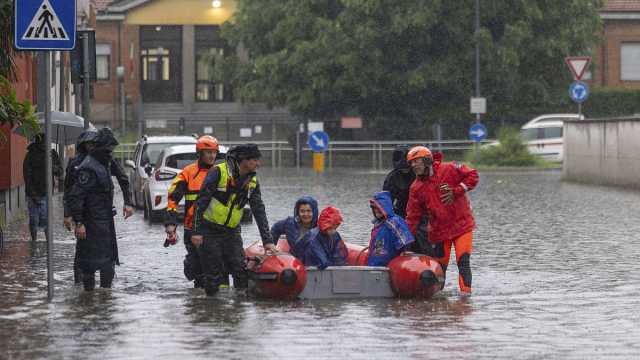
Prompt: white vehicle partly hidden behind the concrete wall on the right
<box><xmin>520</xmin><ymin>114</ymin><xmax>584</xmax><ymax>162</ymax></box>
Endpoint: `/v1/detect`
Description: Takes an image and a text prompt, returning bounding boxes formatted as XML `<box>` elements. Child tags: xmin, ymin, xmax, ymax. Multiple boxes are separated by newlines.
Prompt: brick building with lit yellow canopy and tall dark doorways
<box><xmin>92</xmin><ymin>0</ymin><xmax>291</xmax><ymax>140</ymax></box>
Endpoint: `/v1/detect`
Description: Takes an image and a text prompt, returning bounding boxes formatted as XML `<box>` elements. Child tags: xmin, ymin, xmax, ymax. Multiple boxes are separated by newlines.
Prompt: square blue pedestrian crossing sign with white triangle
<box><xmin>14</xmin><ymin>0</ymin><xmax>76</xmax><ymax>50</ymax></box>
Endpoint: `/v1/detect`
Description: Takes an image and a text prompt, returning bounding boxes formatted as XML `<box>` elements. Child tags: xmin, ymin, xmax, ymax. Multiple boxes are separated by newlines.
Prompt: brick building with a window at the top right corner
<box><xmin>591</xmin><ymin>0</ymin><xmax>640</xmax><ymax>89</ymax></box>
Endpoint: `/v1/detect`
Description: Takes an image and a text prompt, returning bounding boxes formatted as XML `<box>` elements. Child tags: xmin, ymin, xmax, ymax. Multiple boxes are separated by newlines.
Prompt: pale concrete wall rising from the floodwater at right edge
<box><xmin>563</xmin><ymin>117</ymin><xmax>640</xmax><ymax>188</ymax></box>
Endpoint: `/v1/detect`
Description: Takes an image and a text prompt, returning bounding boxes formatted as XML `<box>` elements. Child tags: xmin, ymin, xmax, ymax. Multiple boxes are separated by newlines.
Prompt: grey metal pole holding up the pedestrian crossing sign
<box><xmin>41</xmin><ymin>51</ymin><xmax>53</xmax><ymax>301</ymax></box>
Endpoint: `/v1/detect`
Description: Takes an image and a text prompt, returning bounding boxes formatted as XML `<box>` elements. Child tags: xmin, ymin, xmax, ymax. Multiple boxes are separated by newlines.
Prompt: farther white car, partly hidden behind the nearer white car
<box><xmin>125</xmin><ymin>136</ymin><xmax>196</xmax><ymax>208</ymax></box>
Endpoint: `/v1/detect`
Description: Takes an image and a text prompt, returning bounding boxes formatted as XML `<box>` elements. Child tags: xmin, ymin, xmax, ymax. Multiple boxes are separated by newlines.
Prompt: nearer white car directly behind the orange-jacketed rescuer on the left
<box><xmin>143</xmin><ymin>144</ymin><xmax>227</xmax><ymax>223</ymax></box>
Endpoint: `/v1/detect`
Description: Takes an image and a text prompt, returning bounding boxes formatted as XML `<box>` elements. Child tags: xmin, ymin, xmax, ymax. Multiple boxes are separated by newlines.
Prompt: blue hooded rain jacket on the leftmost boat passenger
<box><xmin>271</xmin><ymin>195</ymin><xmax>318</xmax><ymax>258</ymax></box>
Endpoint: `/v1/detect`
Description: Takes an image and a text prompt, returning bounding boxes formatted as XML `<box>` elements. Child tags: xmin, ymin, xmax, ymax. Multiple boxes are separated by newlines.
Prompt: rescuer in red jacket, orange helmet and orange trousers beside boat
<box><xmin>406</xmin><ymin>146</ymin><xmax>478</xmax><ymax>294</ymax></box>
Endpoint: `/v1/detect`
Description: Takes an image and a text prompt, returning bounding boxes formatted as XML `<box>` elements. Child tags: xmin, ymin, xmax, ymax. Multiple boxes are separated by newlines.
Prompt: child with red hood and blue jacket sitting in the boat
<box><xmin>298</xmin><ymin>206</ymin><xmax>348</xmax><ymax>270</ymax></box>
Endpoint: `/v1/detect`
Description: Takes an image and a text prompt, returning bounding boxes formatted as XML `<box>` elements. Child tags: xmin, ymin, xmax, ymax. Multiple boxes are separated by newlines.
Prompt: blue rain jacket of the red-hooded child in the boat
<box><xmin>299</xmin><ymin>227</ymin><xmax>348</xmax><ymax>270</ymax></box>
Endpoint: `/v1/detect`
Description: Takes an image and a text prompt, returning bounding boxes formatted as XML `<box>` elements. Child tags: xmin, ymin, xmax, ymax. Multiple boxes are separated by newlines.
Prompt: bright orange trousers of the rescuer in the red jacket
<box><xmin>435</xmin><ymin>231</ymin><xmax>473</xmax><ymax>293</ymax></box>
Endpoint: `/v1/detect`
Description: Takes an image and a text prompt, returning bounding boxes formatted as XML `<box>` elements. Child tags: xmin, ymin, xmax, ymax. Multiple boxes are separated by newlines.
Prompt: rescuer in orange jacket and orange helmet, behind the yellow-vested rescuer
<box><xmin>165</xmin><ymin>135</ymin><xmax>218</xmax><ymax>287</ymax></box>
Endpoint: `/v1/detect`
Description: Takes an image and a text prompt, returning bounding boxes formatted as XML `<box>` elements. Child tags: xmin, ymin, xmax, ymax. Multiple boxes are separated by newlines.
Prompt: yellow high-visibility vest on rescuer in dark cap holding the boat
<box><xmin>203</xmin><ymin>162</ymin><xmax>258</xmax><ymax>228</ymax></box>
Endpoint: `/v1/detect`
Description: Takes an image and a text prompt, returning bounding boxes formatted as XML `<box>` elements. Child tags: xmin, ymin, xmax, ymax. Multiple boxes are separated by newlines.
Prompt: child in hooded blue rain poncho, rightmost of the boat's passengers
<box><xmin>367</xmin><ymin>191</ymin><xmax>414</xmax><ymax>266</ymax></box>
